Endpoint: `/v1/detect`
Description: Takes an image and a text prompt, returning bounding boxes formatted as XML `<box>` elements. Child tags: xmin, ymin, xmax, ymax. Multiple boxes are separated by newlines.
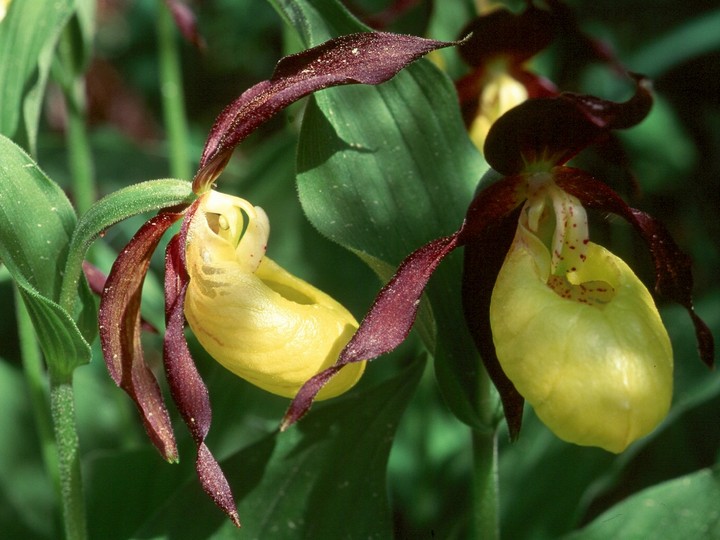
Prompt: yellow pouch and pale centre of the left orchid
<box><xmin>185</xmin><ymin>191</ymin><xmax>365</xmax><ymax>399</ymax></box>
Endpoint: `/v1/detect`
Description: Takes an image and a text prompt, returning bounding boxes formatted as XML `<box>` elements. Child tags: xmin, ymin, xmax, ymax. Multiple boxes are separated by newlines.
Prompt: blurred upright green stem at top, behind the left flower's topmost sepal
<box><xmin>157</xmin><ymin>2</ymin><xmax>192</xmax><ymax>180</ymax></box>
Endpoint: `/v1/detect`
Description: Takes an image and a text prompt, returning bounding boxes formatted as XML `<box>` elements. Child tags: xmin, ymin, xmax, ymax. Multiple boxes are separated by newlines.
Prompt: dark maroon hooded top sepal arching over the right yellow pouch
<box><xmin>484</xmin><ymin>77</ymin><xmax>652</xmax><ymax>175</ymax></box>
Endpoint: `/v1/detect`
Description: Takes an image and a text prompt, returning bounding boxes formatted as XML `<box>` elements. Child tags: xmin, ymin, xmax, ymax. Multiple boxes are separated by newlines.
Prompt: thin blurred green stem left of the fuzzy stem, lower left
<box><xmin>15</xmin><ymin>289</ymin><xmax>61</xmax><ymax>510</ymax></box>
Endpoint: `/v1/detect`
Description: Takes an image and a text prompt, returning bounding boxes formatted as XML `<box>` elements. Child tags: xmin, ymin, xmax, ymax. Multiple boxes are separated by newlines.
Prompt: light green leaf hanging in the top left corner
<box><xmin>0</xmin><ymin>0</ymin><xmax>75</xmax><ymax>148</ymax></box>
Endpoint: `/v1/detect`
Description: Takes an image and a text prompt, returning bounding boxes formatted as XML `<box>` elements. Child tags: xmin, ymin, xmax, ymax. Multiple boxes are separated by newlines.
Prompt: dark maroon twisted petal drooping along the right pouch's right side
<box><xmin>554</xmin><ymin>167</ymin><xmax>715</xmax><ymax>366</ymax></box>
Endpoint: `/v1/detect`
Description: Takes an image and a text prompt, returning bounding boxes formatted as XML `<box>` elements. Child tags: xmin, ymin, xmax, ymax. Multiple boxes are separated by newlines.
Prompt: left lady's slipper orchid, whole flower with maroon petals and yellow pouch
<box><xmin>98</xmin><ymin>29</ymin><xmax>453</xmax><ymax>526</ymax></box>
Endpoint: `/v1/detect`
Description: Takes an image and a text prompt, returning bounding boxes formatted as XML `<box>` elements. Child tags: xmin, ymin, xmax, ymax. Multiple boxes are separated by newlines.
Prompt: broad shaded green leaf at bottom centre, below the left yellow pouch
<box><xmin>136</xmin><ymin>361</ymin><xmax>423</xmax><ymax>539</ymax></box>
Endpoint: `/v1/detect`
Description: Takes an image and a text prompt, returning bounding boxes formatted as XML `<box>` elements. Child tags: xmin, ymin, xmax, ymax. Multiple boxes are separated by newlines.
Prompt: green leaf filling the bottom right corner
<box><xmin>566</xmin><ymin>468</ymin><xmax>720</xmax><ymax>540</ymax></box>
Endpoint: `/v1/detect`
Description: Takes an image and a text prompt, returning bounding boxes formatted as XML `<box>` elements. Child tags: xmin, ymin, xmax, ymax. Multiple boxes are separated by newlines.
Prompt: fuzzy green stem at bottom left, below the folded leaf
<box><xmin>50</xmin><ymin>376</ymin><xmax>87</xmax><ymax>540</ymax></box>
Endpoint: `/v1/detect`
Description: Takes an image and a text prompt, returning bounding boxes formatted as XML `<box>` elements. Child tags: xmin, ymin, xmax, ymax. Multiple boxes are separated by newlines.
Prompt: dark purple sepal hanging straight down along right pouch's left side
<box><xmin>460</xmin><ymin>175</ymin><xmax>527</xmax><ymax>440</ymax></box>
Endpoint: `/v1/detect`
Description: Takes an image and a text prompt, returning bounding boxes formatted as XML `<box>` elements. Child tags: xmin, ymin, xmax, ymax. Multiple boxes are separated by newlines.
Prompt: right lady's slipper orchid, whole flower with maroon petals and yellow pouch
<box><xmin>283</xmin><ymin>78</ymin><xmax>714</xmax><ymax>452</ymax></box>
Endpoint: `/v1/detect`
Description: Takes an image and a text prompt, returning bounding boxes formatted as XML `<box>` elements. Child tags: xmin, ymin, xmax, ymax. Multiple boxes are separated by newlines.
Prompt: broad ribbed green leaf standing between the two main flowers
<box><xmin>297</xmin><ymin>48</ymin><xmax>484</xmax><ymax>426</ymax></box>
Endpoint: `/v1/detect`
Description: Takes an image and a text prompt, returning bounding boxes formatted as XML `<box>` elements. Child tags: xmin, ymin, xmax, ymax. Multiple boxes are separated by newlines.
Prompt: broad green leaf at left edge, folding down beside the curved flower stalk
<box><xmin>0</xmin><ymin>136</ymin><xmax>90</xmax><ymax>375</ymax></box>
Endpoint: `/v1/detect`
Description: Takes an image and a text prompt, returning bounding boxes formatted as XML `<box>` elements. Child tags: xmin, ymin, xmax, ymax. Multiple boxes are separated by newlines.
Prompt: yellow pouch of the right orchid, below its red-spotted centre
<box><xmin>490</xmin><ymin>224</ymin><xmax>673</xmax><ymax>453</ymax></box>
